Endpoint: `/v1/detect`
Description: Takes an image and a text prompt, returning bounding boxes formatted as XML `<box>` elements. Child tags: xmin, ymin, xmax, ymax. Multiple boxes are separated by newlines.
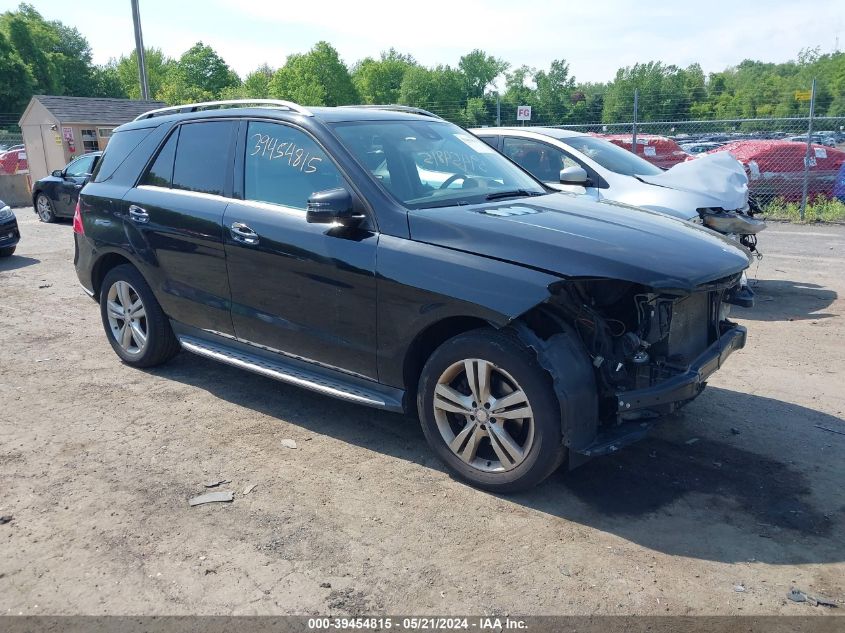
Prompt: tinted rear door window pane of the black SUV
<box><xmin>170</xmin><ymin>121</ymin><xmax>235</xmax><ymax>196</ymax></box>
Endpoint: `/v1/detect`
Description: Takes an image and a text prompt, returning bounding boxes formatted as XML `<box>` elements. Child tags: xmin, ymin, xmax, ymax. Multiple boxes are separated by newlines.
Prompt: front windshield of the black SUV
<box><xmin>334</xmin><ymin>121</ymin><xmax>546</xmax><ymax>209</ymax></box>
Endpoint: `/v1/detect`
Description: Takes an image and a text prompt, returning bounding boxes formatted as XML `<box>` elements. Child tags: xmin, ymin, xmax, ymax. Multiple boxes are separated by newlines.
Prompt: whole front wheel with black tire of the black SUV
<box><xmin>417</xmin><ymin>329</ymin><xmax>565</xmax><ymax>492</ymax></box>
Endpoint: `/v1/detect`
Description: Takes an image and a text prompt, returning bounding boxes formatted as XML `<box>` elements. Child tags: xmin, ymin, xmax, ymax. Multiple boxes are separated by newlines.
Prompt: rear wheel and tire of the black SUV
<box><xmin>100</xmin><ymin>264</ymin><xmax>180</xmax><ymax>367</ymax></box>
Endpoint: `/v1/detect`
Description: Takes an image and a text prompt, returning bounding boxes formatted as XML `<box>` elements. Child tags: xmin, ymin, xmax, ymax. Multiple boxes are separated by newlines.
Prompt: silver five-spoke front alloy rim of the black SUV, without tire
<box><xmin>434</xmin><ymin>358</ymin><xmax>534</xmax><ymax>472</ymax></box>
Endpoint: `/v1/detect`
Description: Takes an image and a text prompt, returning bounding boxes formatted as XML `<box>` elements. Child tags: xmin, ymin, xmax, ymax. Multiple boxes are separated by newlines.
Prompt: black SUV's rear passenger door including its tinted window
<box><xmin>121</xmin><ymin>121</ymin><xmax>237</xmax><ymax>335</ymax></box>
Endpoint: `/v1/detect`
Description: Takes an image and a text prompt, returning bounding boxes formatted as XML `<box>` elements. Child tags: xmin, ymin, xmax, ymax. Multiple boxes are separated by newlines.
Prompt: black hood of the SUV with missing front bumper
<box><xmin>408</xmin><ymin>193</ymin><xmax>750</xmax><ymax>291</ymax></box>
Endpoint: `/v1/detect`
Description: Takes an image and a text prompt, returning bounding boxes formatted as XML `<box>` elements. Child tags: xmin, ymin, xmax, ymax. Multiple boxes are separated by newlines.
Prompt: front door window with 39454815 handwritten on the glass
<box><xmin>244</xmin><ymin>121</ymin><xmax>344</xmax><ymax>209</ymax></box>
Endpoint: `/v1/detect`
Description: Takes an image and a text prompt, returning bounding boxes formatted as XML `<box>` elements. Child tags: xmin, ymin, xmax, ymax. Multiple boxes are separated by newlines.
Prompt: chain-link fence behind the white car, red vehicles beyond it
<box><xmin>412</xmin><ymin>81</ymin><xmax>845</xmax><ymax>220</ymax></box>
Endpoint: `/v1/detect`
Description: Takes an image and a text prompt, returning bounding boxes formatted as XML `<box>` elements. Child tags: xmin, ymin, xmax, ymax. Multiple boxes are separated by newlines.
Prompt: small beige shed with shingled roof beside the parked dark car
<box><xmin>20</xmin><ymin>95</ymin><xmax>165</xmax><ymax>183</ymax></box>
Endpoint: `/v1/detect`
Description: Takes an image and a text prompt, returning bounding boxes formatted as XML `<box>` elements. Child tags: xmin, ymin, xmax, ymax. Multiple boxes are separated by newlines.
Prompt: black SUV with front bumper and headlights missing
<box><xmin>74</xmin><ymin>101</ymin><xmax>749</xmax><ymax>491</ymax></box>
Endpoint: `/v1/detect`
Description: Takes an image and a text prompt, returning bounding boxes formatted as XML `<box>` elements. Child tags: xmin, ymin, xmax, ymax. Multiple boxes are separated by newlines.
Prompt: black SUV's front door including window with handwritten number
<box><xmin>223</xmin><ymin>121</ymin><xmax>378</xmax><ymax>378</ymax></box>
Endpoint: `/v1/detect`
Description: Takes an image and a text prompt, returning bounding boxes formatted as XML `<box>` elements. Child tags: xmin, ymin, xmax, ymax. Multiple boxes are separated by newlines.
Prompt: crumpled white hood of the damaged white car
<box><xmin>637</xmin><ymin>152</ymin><xmax>748</xmax><ymax>211</ymax></box>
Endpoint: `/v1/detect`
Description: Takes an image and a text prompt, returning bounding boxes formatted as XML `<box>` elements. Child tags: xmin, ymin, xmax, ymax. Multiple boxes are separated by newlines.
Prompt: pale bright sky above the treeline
<box><xmin>11</xmin><ymin>0</ymin><xmax>845</xmax><ymax>81</ymax></box>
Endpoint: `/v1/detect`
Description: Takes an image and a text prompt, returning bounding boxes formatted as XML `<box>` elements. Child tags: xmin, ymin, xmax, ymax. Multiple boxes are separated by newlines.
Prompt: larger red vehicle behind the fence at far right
<box><xmin>708</xmin><ymin>141</ymin><xmax>845</xmax><ymax>202</ymax></box>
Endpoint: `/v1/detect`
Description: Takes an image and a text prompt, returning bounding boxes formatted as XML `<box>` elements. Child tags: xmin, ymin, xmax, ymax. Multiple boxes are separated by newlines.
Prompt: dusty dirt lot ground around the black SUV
<box><xmin>0</xmin><ymin>209</ymin><xmax>845</xmax><ymax>615</ymax></box>
